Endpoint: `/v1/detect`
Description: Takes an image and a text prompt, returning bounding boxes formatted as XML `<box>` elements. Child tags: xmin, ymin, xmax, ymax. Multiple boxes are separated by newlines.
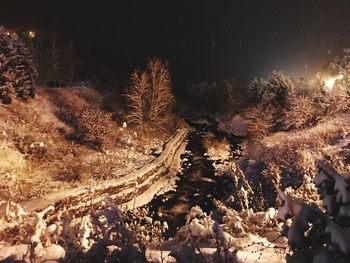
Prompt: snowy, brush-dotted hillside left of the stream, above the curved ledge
<box><xmin>0</xmin><ymin>88</ymin><xmax>166</xmax><ymax>201</ymax></box>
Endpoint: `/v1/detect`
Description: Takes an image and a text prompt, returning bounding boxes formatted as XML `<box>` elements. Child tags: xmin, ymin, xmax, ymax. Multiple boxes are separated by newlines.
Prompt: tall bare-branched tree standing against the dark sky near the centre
<box><xmin>126</xmin><ymin>59</ymin><xmax>175</xmax><ymax>131</ymax></box>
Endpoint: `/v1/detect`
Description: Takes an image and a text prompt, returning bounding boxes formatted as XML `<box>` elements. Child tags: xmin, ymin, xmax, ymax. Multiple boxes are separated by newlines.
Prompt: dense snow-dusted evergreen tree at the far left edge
<box><xmin>0</xmin><ymin>27</ymin><xmax>37</xmax><ymax>104</ymax></box>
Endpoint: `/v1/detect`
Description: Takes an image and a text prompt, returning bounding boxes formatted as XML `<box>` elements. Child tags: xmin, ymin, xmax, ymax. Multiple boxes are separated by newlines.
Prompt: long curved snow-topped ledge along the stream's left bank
<box><xmin>15</xmin><ymin>128</ymin><xmax>188</xmax><ymax>217</ymax></box>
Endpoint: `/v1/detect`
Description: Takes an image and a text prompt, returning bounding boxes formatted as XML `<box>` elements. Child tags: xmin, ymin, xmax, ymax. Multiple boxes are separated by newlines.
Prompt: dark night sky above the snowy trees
<box><xmin>0</xmin><ymin>0</ymin><xmax>350</xmax><ymax>81</ymax></box>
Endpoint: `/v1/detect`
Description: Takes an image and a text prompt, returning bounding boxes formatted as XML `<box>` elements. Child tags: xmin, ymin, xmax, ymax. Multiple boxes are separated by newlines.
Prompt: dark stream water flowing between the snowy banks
<box><xmin>147</xmin><ymin>118</ymin><xmax>241</xmax><ymax>238</ymax></box>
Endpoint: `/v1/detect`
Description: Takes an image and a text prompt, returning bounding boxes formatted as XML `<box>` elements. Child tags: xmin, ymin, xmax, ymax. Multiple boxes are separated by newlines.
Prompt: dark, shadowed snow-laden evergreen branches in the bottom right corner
<box><xmin>276</xmin><ymin>161</ymin><xmax>350</xmax><ymax>263</ymax></box>
